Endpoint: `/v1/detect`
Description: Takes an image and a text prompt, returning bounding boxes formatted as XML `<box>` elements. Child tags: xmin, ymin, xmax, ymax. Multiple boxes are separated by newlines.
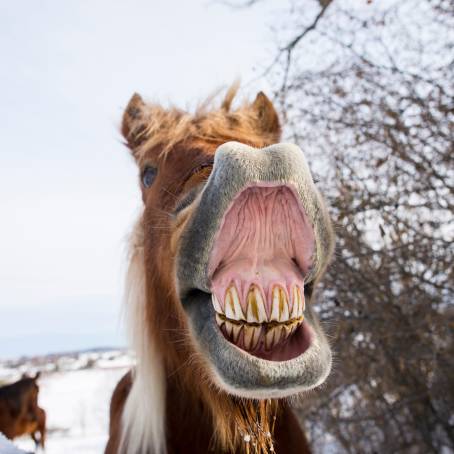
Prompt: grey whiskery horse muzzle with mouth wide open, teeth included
<box><xmin>177</xmin><ymin>142</ymin><xmax>333</xmax><ymax>398</ymax></box>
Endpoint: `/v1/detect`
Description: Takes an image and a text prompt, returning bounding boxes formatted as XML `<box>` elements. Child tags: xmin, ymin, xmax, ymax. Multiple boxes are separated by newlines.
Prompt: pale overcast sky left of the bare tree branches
<box><xmin>0</xmin><ymin>0</ymin><xmax>280</xmax><ymax>357</ymax></box>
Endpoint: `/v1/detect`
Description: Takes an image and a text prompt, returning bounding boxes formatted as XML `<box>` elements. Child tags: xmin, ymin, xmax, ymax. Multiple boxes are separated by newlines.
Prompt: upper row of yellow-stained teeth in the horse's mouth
<box><xmin>211</xmin><ymin>284</ymin><xmax>305</xmax><ymax>324</ymax></box>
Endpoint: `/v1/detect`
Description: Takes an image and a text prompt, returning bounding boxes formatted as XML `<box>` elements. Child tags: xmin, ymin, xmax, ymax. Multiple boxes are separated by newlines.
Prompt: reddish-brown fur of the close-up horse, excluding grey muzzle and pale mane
<box><xmin>106</xmin><ymin>89</ymin><xmax>309</xmax><ymax>454</ymax></box>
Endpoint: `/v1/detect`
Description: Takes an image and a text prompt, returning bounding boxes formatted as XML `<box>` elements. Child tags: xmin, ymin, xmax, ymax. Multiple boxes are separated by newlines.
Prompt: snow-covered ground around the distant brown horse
<box><xmin>0</xmin><ymin>351</ymin><xmax>133</xmax><ymax>454</ymax></box>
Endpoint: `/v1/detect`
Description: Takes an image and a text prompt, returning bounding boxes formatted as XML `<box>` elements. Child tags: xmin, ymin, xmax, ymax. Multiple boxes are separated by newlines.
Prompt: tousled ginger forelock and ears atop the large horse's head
<box><xmin>121</xmin><ymin>85</ymin><xmax>280</xmax><ymax>162</ymax></box>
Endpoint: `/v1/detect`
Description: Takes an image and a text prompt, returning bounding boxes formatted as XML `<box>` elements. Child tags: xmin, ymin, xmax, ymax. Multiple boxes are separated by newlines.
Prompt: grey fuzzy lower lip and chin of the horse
<box><xmin>183</xmin><ymin>291</ymin><xmax>331</xmax><ymax>398</ymax></box>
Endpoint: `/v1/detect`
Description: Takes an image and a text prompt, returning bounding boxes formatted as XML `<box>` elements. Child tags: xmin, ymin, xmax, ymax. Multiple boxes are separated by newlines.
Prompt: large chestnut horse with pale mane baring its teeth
<box><xmin>105</xmin><ymin>86</ymin><xmax>334</xmax><ymax>454</ymax></box>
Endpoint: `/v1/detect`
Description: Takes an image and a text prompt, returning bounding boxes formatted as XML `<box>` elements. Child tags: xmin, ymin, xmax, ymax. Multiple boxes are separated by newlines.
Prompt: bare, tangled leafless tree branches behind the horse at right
<box><xmin>232</xmin><ymin>0</ymin><xmax>454</xmax><ymax>453</ymax></box>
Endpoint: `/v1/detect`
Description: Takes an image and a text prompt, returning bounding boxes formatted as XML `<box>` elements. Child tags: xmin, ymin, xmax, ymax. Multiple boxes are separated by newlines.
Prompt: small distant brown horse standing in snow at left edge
<box><xmin>0</xmin><ymin>372</ymin><xmax>46</xmax><ymax>449</ymax></box>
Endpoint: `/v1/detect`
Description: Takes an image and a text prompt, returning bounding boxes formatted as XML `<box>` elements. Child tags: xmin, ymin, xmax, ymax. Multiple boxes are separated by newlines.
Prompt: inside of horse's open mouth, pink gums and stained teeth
<box><xmin>209</xmin><ymin>184</ymin><xmax>314</xmax><ymax>361</ymax></box>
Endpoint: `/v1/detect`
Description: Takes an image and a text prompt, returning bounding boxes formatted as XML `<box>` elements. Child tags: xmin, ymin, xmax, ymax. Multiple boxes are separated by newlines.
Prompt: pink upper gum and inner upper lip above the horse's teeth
<box><xmin>209</xmin><ymin>184</ymin><xmax>314</xmax><ymax>315</ymax></box>
